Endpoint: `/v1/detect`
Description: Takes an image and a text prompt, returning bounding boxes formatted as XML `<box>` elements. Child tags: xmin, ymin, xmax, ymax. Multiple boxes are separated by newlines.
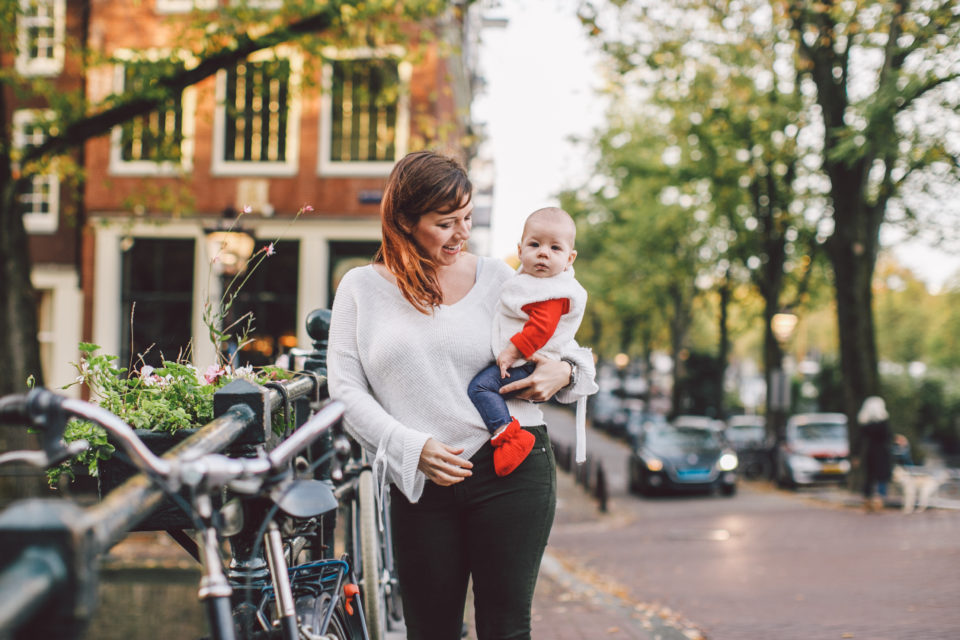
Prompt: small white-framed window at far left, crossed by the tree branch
<box><xmin>13</xmin><ymin>110</ymin><xmax>60</xmax><ymax>233</ymax></box>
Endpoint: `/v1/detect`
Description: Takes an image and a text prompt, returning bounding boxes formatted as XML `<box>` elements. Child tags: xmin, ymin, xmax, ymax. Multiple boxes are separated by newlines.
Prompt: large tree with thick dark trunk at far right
<box><xmin>581</xmin><ymin>0</ymin><xmax>960</xmax><ymax>450</ymax></box>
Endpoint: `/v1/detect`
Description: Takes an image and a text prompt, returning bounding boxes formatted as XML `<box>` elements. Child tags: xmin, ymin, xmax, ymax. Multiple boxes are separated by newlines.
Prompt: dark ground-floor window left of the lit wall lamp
<box><xmin>120</xmin><ymin>237</ymin><xmax>195</xmax><ymax>369</ymax></box>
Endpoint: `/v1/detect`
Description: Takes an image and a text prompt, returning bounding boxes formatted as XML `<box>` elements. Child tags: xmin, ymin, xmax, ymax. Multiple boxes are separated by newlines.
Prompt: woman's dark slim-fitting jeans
<box><xmin>391</xmin><ymin>426</ymin><xmax>557</xmax><ymax>640</ymax></box>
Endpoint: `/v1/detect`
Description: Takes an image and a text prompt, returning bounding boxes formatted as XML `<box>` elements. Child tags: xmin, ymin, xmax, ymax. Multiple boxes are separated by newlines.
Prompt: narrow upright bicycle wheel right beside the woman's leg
<box><xmin>354</xmin><ymin>469</ymin><xmax>387</xmax><ymax>640</ymax></box>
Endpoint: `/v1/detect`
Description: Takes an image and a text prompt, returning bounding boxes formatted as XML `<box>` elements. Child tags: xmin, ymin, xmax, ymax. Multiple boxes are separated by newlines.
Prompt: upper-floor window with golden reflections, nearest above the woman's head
<box><xmin>320</xmin><ymin>56</ymin><xmax>409</xmax><ymax>175</ymax></box>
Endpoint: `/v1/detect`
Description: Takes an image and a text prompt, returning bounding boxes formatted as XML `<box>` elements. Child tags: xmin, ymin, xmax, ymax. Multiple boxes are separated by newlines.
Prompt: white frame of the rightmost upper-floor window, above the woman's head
<box><xmin>317</xmin><ymin>46</ymin><xmax>413</xmax><ymax>177</ymax></box>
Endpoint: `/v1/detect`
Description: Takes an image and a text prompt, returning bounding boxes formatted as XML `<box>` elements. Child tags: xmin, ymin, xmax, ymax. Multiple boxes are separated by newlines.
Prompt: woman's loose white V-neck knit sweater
<box><xmin>327</xmin><ymin>258</ymin><xmax>596</xmax><ymax>502</ymax></box>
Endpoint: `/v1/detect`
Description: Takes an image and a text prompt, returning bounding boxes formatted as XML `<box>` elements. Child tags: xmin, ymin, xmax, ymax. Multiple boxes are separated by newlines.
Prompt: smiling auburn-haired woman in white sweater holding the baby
<box><xmin>328</xmin><ymin>151</ymin><xmax>596</xmax><ymax>640</ymax></box>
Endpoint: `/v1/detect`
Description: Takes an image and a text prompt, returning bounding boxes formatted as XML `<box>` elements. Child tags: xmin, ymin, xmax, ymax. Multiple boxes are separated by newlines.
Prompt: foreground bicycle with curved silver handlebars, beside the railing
<box><xmin>0</xmin><ymin>389</ymin><xmax>368</xmax><ymax>640</ymax></box>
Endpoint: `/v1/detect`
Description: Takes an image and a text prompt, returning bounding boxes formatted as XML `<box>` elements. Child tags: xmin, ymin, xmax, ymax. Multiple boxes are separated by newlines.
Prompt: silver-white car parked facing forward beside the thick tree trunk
<box><xmin>776</xmin><ymin>413</ymin><xmax>850</xmax><ymax>487</ymax></box>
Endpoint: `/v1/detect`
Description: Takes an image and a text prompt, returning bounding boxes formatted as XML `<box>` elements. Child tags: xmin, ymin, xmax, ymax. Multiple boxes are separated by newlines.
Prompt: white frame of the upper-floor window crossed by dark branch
<box><xmin>109</xmin><ymin>49</ymin><xmax>197</xmax><ymax>176</ymax></box>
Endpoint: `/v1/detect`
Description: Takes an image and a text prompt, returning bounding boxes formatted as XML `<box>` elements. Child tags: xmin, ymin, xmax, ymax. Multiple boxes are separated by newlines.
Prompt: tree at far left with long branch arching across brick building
<box><xmin>0</xmin><ymin>0</ymin><xmax>446</xmax><ymax>394</ymax></box>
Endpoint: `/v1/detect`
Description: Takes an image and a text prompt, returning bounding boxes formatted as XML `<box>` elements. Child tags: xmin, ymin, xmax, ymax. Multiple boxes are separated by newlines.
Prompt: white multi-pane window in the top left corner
<box><xmin>16</xmin><ymin>0</ymin><xmax>67</xmax><ymax>76</ymax></box>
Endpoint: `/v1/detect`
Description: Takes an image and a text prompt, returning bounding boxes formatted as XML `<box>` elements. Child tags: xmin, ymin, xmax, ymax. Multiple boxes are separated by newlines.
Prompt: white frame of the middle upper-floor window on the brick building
<box><xmin>210</xmin><ymin>45</ymin><xmax>303</xmax><ymax>177</ymax></box>
